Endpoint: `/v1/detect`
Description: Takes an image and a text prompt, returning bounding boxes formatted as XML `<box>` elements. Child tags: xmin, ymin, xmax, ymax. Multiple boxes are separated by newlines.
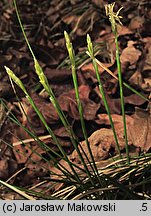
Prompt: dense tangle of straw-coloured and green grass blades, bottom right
<box><xmin>57</xmin><ymin>153</ymin><xmax>151</xmax><ymax>200</ymax></box>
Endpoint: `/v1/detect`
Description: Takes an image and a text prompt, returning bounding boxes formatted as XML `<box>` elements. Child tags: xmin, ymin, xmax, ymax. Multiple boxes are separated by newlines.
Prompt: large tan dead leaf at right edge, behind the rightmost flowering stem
<box><xmin>96</xmin><ymin>103</ymin><xmax>151</xmax><ymax>152</ymax></box>
